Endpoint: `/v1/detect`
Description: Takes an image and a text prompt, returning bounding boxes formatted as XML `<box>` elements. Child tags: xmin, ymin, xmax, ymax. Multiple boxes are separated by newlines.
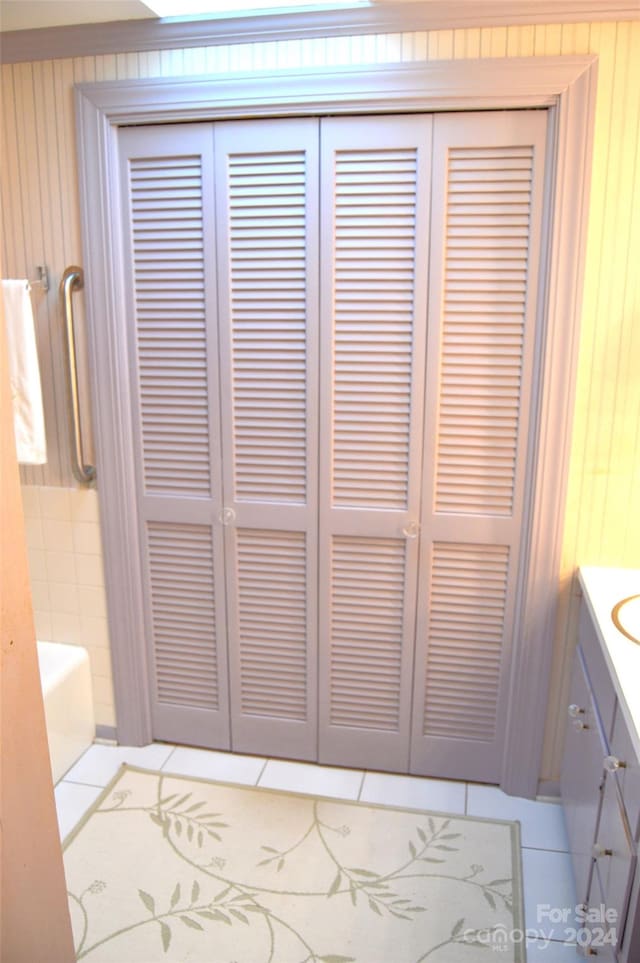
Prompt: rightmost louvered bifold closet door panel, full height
<box><xmin>411</xmin><ymin>111</ymin><xmax>547</xmax><ymax>782</ymax></box>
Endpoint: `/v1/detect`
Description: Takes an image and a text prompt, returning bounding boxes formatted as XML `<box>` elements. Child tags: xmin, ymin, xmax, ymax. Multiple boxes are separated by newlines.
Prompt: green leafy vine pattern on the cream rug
<box><xmin>69</xmin><ymin>774</ymin><xmax>513</xmax><ymax>963</ymax></box>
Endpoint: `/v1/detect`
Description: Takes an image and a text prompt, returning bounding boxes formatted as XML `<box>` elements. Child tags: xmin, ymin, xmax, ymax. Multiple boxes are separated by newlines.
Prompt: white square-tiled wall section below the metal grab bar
<box><xmin>22</xmin><ymin>485</ymin><xmax>116</xmax><ymax>726</ymax></box>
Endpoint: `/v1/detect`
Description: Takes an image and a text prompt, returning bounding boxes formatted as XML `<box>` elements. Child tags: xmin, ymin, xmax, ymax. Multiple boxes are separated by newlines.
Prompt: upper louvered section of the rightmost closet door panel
<box><xmin>436</xmin><ymin>147</ymin><xmax>533</xmax><ymax>515</ymax></box>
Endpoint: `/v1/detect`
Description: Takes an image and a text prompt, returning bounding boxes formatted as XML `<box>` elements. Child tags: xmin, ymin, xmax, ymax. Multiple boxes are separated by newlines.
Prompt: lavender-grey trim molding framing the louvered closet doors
<box><xmin>75</xmin><ymin>56</ymin><xmax>597</xmax><ymax>797</ymax></box>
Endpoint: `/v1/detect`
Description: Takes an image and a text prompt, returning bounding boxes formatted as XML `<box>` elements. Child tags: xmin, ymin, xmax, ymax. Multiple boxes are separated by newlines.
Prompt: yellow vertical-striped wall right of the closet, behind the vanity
<box><xmin>543</xmin><ymin>22</ymin><xmax>640</xmax><ymax>778</ymax></box>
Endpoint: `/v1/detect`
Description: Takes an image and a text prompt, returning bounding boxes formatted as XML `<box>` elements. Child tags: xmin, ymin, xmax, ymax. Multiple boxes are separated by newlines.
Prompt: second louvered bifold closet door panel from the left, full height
<box><xmin>216</xmin><ymin>119</ymin><xmax>318</xmax><ymax>759</ymax></box>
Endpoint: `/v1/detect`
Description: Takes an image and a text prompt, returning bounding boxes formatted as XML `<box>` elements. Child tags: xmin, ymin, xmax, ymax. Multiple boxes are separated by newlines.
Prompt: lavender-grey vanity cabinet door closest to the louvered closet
<box><xmin>560</xmin><ymin>649</ymin><xmax>606</xmax><ymax>903</ymax></box>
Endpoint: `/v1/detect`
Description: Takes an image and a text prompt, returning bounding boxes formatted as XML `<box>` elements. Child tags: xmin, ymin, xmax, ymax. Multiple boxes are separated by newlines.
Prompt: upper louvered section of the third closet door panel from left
<box><xmin>333</xmin><ymin>149</ymin><xmax>417</xmax><ymax>508</ymax></box>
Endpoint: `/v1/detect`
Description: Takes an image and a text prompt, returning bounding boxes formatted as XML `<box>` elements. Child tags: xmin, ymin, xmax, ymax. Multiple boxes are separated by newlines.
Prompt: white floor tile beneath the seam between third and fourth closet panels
<box><xmin>360</xmin><ymin>772</ymin><xmax>465</xmax><ymax>814</ymax></box>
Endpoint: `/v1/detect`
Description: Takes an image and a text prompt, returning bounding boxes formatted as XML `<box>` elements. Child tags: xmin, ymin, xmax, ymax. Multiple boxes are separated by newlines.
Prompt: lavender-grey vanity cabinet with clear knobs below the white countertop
<box><xmin>561</xmin><ymin>584</ymin><xmax>640</xmax><ymax>963</ymax></box>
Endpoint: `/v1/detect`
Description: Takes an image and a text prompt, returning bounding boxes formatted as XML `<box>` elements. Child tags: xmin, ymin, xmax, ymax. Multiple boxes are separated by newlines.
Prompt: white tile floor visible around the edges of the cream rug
<box><xmin>55</xmin><ymin>743</ymin><xmax>583</xmax><ymax>963</ymax></box>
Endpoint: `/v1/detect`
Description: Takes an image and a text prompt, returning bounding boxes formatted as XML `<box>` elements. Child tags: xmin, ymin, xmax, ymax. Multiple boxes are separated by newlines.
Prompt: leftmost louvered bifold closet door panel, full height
<box><xmin>119</xmin><ymin>125</ymin><xmax>229</xmax><ymax>748</ymax></box>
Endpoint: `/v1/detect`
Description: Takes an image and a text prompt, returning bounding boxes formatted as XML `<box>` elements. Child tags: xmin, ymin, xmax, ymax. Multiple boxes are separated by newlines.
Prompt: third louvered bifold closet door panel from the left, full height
<box><xmin>319</xmin><ymin>117</ymin><xmax>431</xmax><ymax>771</ymax></box>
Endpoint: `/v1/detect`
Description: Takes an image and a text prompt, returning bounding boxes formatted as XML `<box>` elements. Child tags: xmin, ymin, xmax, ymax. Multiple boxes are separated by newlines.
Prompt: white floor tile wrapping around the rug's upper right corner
<box><xmin>467</xmin><ymin>784</ymin><xmax>569</xmax><ymax>852</ymax></box>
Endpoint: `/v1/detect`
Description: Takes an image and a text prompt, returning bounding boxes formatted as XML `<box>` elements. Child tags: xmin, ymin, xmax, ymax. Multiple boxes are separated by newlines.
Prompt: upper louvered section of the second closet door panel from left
<box><xmin>227</xmin><ymin>151</ymin><xmax>307</xmax><ymax>504</ymax></box>
